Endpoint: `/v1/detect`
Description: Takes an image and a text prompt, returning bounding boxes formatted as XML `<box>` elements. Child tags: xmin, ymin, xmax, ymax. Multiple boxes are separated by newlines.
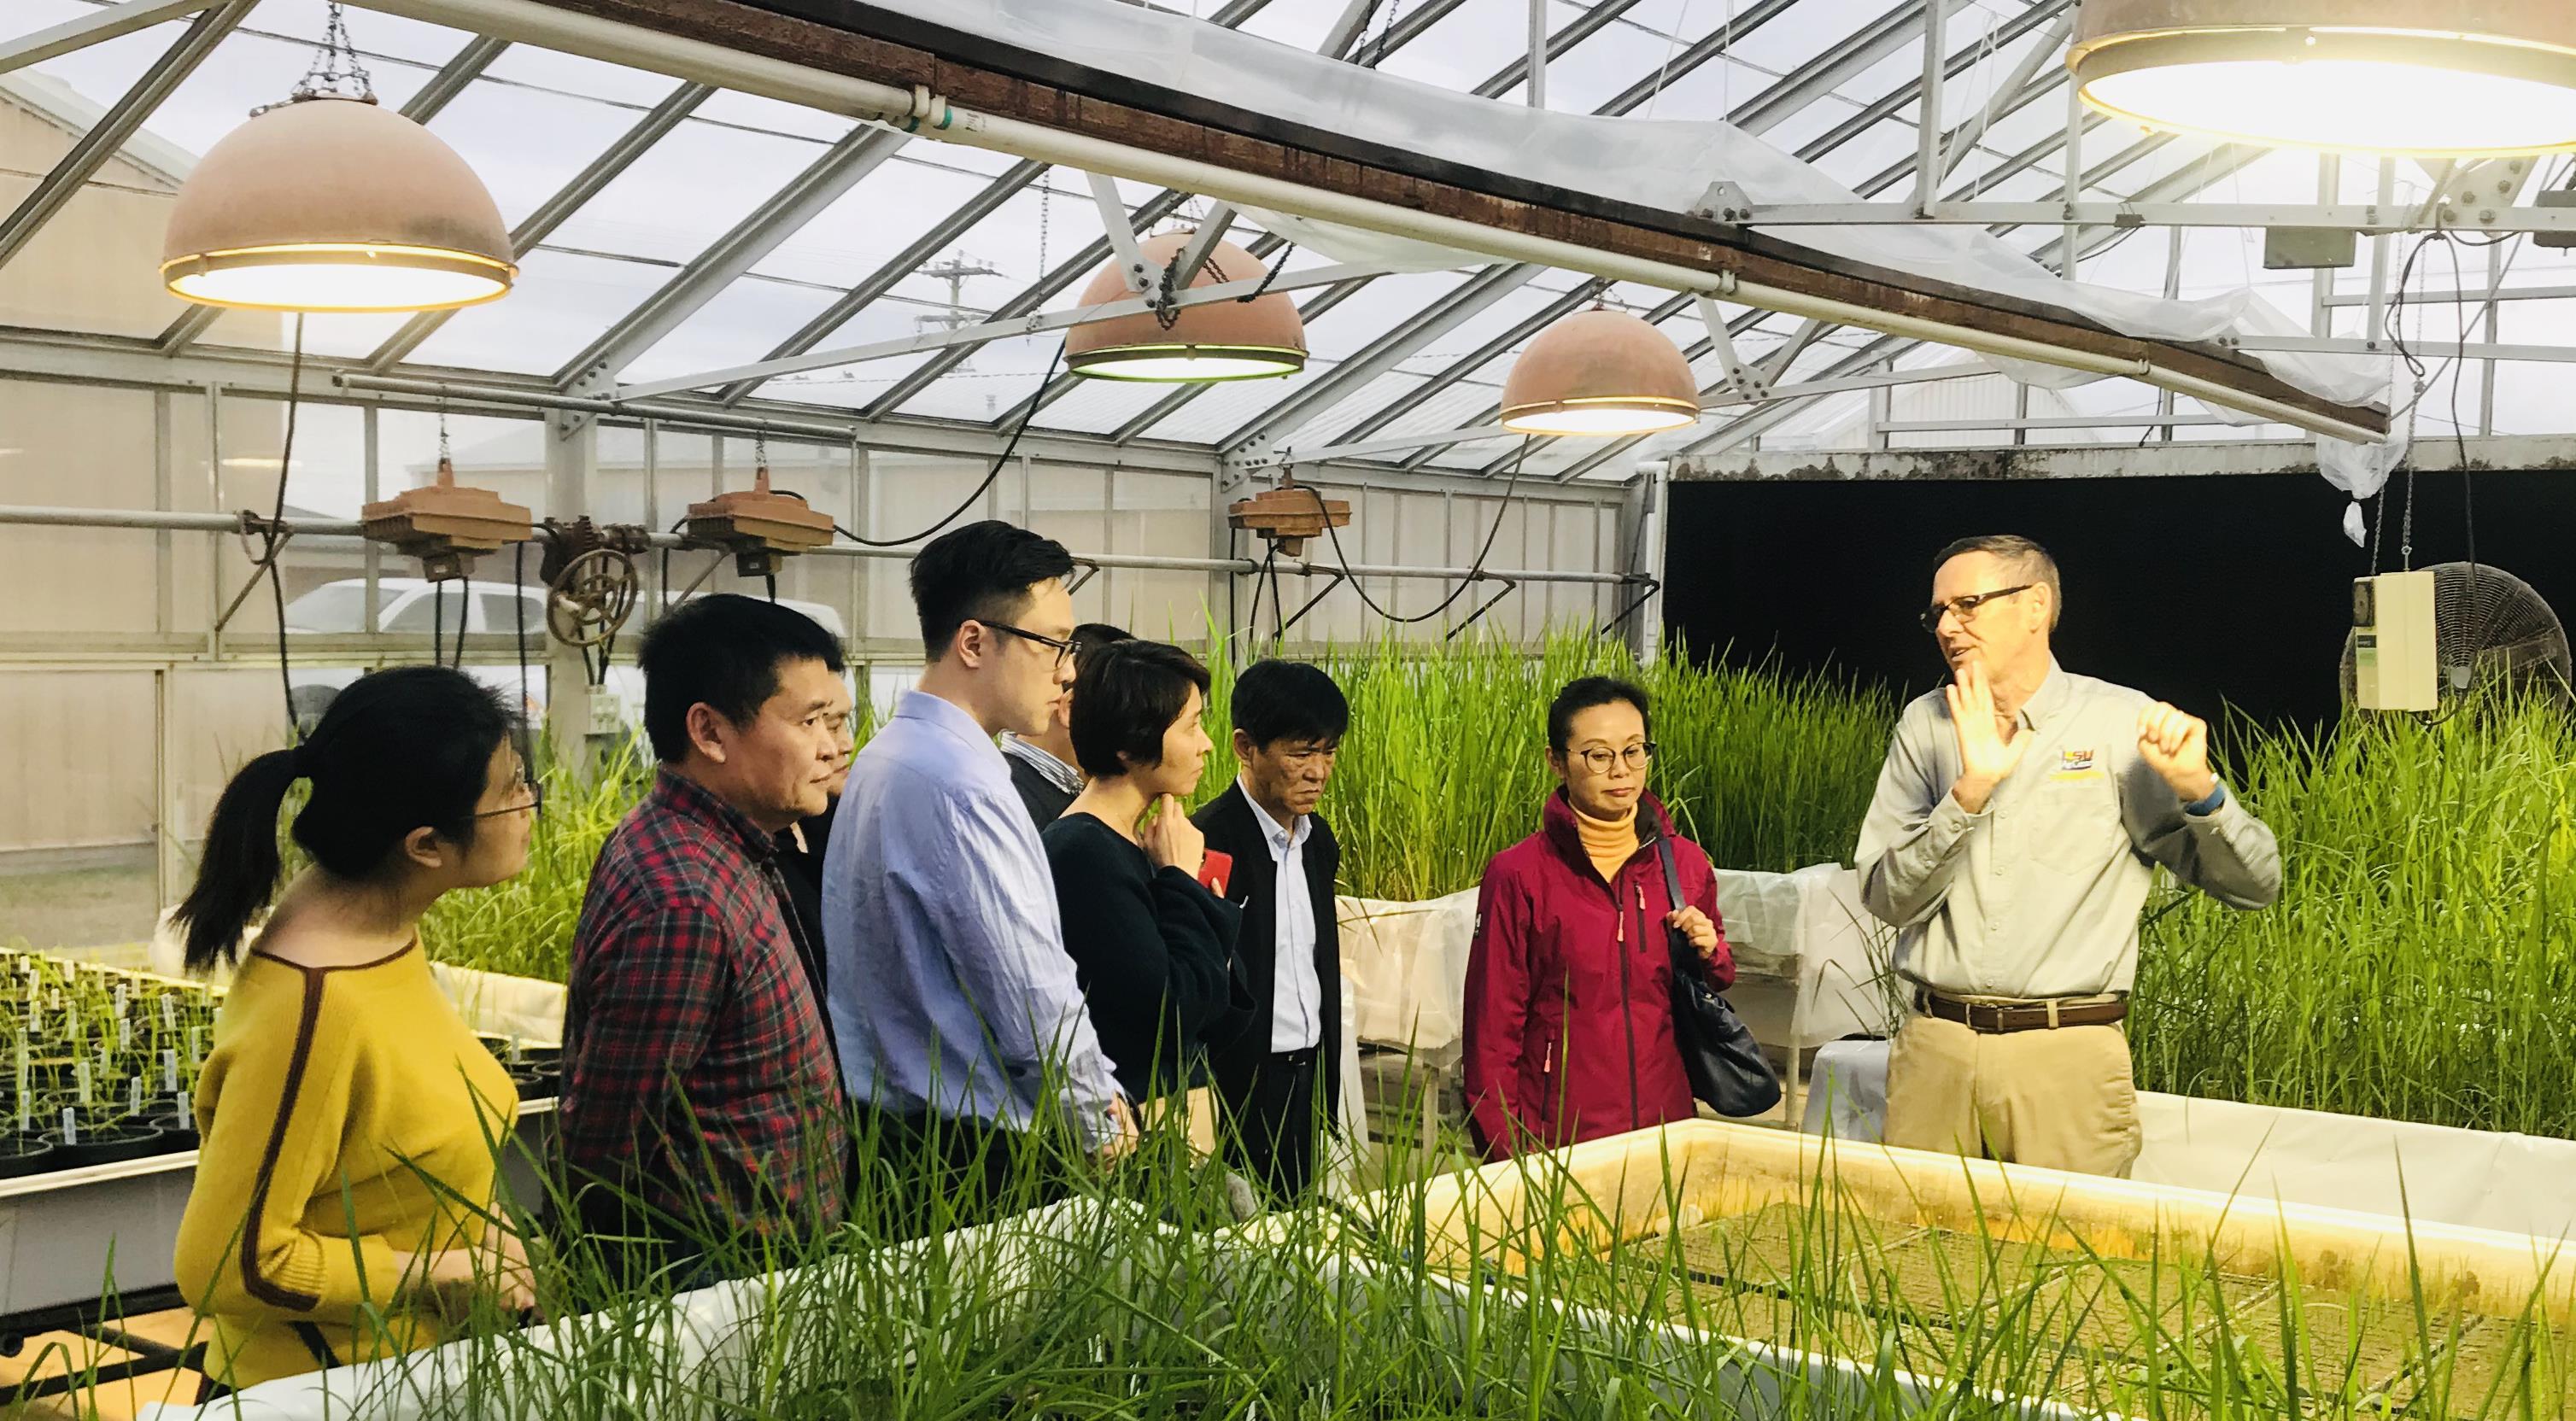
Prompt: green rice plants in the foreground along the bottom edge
<box><xmin>120</xmin><ymin>1076</ymin><xmax>2571</xmax><ymax>1421</ymax></box>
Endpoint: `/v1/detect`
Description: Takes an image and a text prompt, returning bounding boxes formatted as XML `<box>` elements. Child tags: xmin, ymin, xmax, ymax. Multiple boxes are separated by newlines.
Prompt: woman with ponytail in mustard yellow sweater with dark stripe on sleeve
<box><xmin>178</xmin><ymin>667</ymin><xmax>536</xmax><ymax>1393</ymax></box>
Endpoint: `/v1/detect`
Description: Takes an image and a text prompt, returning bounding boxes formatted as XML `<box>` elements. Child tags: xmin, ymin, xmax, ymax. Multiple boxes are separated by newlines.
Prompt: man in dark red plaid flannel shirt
<box><xmin>556</xmin><ymin>594</ymin><xmax>850</xmax><ymax>1284</ymax></box>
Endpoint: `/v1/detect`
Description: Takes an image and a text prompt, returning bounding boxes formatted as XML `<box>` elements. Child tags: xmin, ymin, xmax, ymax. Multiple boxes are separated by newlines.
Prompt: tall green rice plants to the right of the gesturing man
<box><xmin>2130</xmin><ymin>700</ymin><xmax>2576</xmax><ymax>1135</ymax></box>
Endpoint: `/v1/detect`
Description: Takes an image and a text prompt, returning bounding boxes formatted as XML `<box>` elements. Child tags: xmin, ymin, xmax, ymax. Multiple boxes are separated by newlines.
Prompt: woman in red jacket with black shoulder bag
<box><xmin>1466</xmin><ymin>677</ymin><xmax>1736</xmax><ymax>1159</ymax></box>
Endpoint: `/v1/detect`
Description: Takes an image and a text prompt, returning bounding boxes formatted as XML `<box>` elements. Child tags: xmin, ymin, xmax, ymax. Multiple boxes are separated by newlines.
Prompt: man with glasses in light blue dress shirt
<box><xmin>824</xmin><ymin>523</ymin><xmax>1136</xmax><ymax>1223</ymax></box>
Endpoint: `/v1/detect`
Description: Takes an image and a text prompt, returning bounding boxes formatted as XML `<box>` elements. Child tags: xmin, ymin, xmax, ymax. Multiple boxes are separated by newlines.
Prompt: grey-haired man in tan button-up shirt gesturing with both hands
<box><xmin>1858</xmin><ymin>538</ymin><xmax>2280</xmax><ymax>1174</ymax></box>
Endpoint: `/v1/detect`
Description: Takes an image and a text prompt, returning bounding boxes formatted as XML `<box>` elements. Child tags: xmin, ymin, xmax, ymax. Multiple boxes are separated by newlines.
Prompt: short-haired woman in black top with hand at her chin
<box><xmin>1040</xmin><ymin>641</ymin><xmax>1250</xmax><ymax>1104</ymax></box>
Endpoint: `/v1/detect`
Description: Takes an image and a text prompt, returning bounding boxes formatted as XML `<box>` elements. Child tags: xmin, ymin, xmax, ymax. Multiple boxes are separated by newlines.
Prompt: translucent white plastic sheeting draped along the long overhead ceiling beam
<box><xmin>935</xmin><ymin>0</ymin><xmax>2388</xmax><ymax>419</ymax></box>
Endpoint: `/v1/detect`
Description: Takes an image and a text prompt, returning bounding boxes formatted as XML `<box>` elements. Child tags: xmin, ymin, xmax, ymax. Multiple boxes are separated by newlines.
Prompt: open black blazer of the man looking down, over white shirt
<box><xmin>1190</xmin><ymin>782</ymin><xmax>1342</xmax><ymax>1120</ymax></box>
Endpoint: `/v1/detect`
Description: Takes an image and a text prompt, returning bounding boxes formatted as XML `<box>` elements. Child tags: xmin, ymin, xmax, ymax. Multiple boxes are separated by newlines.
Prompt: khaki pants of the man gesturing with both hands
<box><xmin>1886</xmin><ymin>1015</ymin><xmax>2138</xmax><ymax>1179</ymax></box>
